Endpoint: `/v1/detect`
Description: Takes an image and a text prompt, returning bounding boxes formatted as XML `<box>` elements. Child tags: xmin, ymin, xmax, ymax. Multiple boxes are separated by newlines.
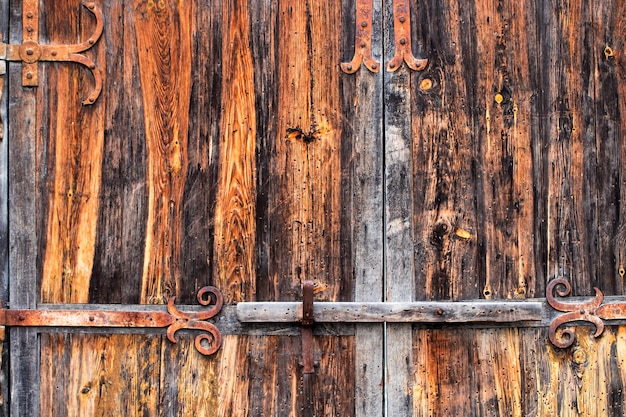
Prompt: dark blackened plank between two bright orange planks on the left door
<box><xmin>178</xmin><ymin>1</ymin><xmax>223</xmax><ymax>303</ymax></box>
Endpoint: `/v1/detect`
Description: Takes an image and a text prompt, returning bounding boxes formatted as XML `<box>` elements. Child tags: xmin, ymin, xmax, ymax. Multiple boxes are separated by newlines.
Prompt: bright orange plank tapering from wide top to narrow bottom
<box><xmin>133</xmin><ymin>0</ymin><xmax>195</xmax><ymax>303</ymax></box>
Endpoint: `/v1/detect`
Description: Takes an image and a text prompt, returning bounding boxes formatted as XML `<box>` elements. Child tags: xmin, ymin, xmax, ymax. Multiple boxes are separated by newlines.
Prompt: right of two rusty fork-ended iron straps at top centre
<box><xmin>387</xmin><ymin>0</ymin><xmax>428</xmax><ymax>72</ymax></box>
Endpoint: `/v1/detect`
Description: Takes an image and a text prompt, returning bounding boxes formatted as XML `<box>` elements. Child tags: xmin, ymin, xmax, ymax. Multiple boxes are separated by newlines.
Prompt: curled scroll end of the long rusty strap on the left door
<box><xmin>166</xmin><ymin>286</ymin><xmax>224</xmax><ymax>356</ymax></box>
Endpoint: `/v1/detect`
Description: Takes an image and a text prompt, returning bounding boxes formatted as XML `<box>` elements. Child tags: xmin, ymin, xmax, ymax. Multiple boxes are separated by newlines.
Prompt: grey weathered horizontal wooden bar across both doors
<box><xmin>237</xmin><ymin>301</ymin><xmax>544</xmax><ymax>323</ymax></box>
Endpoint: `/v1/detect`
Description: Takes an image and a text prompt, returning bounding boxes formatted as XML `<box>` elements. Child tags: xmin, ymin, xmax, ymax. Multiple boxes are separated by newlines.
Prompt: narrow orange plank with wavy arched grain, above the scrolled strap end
<box><xmin>213</xmin><ymin>0</ymin><xmax>256</xmax><ymax>303</ymax></box>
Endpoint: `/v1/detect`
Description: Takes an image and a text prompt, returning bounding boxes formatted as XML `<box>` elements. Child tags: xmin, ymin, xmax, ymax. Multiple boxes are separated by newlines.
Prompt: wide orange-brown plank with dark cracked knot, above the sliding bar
<box><xmin>268</xmin><ymin>1</ymin><xmax>352</xmax><ymax>301</ymax></box>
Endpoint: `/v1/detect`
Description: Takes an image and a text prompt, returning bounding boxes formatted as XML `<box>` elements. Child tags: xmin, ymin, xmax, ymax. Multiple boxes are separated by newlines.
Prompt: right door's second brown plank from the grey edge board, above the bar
<box><xmin>470</xmin><ymin>0</ymin><xmax>535</xmax><ymax>299</ymax></box>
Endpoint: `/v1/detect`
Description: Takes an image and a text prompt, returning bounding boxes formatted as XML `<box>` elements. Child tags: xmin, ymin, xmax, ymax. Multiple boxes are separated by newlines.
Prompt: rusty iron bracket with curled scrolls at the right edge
<box><xmin>546</xmin><ymin>278</ymin><xmax>626</xmax><ymax>349</ymax></box>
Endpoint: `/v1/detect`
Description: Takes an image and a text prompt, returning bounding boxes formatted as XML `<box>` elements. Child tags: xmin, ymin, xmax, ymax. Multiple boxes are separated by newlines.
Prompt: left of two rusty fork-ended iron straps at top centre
<box><xmin>341</xmin><ymin>0</ymin><xmax>380</xmax><ymax>74</ymax></box>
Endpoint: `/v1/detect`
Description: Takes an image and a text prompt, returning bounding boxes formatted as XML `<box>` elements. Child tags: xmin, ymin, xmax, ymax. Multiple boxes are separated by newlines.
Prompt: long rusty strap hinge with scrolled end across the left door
<box><xmin>0</xmin><ymin>286</ymin><xmax>224</xmax><ymax>355</ymax></box>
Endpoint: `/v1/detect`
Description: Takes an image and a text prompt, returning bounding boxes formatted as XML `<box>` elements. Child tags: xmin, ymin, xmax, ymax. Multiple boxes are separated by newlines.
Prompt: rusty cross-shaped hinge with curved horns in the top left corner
<box><xmin>0</xmin><ymin>0</ymin><xmax>104</xmax><ymax>105</ymax></box>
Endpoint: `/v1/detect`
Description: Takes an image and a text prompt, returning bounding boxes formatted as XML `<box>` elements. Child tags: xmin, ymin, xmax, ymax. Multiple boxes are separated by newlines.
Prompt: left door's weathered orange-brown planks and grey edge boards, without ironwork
<box><xmin>10</xmin><ymin>0</ymin><xmax>383</xmax><ymax>416</ymax></box>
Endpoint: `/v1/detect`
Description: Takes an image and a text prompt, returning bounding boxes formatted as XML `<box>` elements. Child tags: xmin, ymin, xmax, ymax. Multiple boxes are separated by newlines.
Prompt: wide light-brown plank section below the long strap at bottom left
<box><xmin>41</xmin><ymin>334</ymin><xmax>162</xmax><ymax>417</ymax></box>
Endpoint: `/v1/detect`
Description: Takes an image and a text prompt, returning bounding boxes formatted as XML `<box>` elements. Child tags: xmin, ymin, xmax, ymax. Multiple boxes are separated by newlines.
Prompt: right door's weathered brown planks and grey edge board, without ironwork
<box><xmin>384</xmin><ymin>1</ymin><xmax>626</xmax><ymax>416</ymax></box>
